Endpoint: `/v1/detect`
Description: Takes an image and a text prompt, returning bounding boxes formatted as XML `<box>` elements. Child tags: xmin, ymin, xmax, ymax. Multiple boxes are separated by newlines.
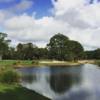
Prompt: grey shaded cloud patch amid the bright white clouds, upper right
<box><xmin>56</xmin><ymin>8</ymin><xmax>92</xmax><ymax>29</ymax></box>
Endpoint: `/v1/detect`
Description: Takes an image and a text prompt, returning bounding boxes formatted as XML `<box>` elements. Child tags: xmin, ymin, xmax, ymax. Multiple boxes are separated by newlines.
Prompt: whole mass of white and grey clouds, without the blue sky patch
<box><xmin>0</xmin><ymin>0</ymin><xmax>100</xmax><ymax>49</ymax></box>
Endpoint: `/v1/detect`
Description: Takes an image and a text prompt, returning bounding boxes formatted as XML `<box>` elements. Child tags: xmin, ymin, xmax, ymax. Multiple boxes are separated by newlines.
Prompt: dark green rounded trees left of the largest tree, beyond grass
<box><xmin>16</xmin><ymin>43</ymin><xmax>37</xmax><ymax>60</ymax></box>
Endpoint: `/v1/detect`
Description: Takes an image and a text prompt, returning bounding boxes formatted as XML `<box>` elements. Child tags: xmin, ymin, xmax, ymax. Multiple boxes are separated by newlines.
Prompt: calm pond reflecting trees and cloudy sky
<box><xmin>18</xmin><ymin>64</ymin><xmax>100</xmax><ymax>100</ymax></box>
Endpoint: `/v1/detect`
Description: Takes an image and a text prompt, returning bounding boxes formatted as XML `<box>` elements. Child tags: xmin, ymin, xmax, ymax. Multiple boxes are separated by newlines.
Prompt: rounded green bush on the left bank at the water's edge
<box><xmin>0</xmin><ymin>70</ymin><xmax>20</xmax><ymax>84</ymax></box>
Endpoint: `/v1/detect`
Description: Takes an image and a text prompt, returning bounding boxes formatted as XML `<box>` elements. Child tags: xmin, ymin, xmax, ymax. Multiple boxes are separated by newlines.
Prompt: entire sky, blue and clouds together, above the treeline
<box><xmin>0</xmin><ymin>0</ymin><xmax>100</xmax><ymax>50</ymax></box>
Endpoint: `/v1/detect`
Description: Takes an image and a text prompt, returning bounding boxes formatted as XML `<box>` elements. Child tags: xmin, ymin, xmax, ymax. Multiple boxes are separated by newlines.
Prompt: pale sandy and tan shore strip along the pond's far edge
<box><xmin>14</xmin><ymin>60</ymin><xmax>96</xmax><ymax>68</ymax></box>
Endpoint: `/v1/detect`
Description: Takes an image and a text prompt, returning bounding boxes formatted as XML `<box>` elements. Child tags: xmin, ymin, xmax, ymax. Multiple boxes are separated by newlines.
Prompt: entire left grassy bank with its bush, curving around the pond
<box><xmin>0</xmin><ymin>60</ymin><xmax>49</xmax><ymax>100</ymax></box>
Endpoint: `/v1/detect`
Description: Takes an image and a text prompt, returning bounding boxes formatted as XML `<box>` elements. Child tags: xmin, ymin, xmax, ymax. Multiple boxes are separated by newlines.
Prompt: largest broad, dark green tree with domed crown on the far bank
<box><xmin>47</xmin><ymin>33</ymin><xmax>84</xmax><ymax>60</ymax></box>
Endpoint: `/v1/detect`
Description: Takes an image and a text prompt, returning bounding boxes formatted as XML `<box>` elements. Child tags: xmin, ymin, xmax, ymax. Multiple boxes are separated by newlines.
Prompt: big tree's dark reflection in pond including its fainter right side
<box><xmin>50</xmin><ymin>68</ymin><xmax>81</xmax><ymax>93</ymax></box>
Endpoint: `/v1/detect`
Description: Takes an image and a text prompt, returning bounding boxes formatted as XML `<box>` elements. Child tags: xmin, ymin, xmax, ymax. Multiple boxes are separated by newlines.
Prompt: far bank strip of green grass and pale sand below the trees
<box><xmin>0</xmin><ymin>60</ymin><xmax>97</xmax><ymax>70</ymax></box>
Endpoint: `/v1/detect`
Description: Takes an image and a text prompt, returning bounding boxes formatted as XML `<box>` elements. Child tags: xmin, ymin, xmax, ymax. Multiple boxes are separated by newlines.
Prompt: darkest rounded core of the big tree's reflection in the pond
<box><xmin>50</xmin><ymin>74</ymin><xmax>72</xmax><ymax>93</ymax></box>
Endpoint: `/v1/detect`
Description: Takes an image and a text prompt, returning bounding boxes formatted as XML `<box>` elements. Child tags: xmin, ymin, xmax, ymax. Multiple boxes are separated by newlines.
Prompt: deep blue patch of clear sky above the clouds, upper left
<box><xmin>0</xmin><ymin>0</ymin><xmax>53</xmax><ymax>18</ymax></box>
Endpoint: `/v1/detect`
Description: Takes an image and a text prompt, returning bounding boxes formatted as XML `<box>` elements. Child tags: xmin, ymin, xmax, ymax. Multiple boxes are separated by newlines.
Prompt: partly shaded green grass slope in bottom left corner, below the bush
<box><xmin>0</xmin><ymin>84</ymin><xmax>50</xmax><ymax>100</ymax></box>
